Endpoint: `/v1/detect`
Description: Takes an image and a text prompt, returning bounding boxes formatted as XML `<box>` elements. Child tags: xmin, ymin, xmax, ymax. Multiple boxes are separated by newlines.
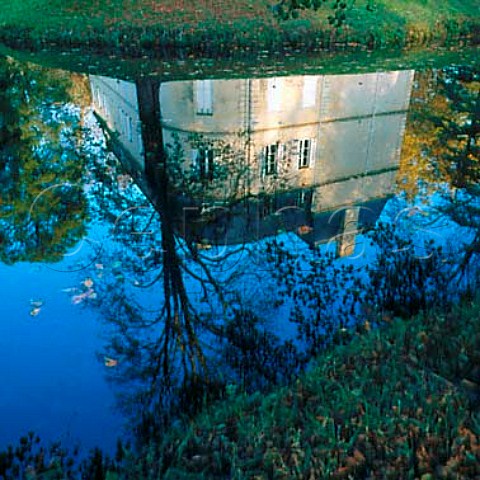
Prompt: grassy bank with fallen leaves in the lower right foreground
<box><xmin>132</xmin><ymin>303</ymin><xmax>480</xmax><ymax>480</ymax></box>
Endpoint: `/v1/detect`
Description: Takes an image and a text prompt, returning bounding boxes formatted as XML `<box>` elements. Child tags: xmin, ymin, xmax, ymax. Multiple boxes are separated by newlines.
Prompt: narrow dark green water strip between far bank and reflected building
<box><xmin>0</xmin><ymin>44</ymin><xmax>479</xmax><ymax>81</ymax></box>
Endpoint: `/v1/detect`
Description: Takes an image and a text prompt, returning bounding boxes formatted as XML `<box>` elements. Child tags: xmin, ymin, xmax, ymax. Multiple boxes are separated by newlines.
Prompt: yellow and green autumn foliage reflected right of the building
<box><xmin>399</xmin><ymin>67</ymin><xmax>478</xmax><ymax>198</ymax></box>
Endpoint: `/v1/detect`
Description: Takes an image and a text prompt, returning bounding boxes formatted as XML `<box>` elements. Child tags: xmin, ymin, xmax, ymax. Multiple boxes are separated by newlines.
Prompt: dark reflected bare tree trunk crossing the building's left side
<box><xmin>136</xmin><ymin>78</ymin><xmax>205</xmax><ymax>402</ymax></box>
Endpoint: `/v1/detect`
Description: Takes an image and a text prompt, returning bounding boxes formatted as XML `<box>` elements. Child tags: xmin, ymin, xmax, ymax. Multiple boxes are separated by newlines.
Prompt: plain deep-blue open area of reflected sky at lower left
<box><xmin>0</xmin><ymin>244</ymin><xmax>121</xmax><ymax>451</ymax></box>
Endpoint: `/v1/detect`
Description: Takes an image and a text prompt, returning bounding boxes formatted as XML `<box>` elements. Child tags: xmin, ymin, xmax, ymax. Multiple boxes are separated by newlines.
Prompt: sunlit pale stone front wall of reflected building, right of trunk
<box><xmin>160</xmin><ymin>71</ymin><xmax>413</xmax><ymax>201</ymax></box>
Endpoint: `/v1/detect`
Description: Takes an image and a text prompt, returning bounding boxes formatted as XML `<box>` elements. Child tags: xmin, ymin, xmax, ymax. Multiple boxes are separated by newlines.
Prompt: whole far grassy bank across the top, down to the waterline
<box><xmin>0</xmin><ymin>0</ymin><xmax>480</xmax><ymax>58</ymax></box>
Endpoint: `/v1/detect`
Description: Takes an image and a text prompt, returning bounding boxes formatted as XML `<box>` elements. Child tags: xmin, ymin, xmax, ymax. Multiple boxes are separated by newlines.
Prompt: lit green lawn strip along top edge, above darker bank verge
<box><xmin>0</xmin><ymin>0</ymin><xmax>480</xmax><ymax>30</ymax></box>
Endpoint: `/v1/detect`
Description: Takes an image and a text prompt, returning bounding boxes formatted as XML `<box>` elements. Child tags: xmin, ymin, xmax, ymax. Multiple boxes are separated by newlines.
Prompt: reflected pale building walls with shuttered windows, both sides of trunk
<box><xmin>91</xmin><ymin>71</ymin><xmax>413</xmax><ymax>255</ymax></box>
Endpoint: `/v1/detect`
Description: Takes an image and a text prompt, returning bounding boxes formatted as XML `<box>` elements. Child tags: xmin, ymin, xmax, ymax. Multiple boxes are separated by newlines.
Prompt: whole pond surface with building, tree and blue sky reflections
<box><xmin>0</xmin><ymin>51</ymin><xmax>480</xmax><ymax>452</ymax></box>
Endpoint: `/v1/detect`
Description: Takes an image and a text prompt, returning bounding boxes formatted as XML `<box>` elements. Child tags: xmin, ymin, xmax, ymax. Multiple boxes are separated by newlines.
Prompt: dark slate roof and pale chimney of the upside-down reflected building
<box><xmin>180</xmin><ymin>192</ymin><xmax>387</xmax><ymax>256</ymax></box>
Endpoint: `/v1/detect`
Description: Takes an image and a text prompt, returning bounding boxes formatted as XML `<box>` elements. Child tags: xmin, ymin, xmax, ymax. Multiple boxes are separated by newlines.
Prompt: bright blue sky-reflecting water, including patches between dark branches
<box><xmin>0</xmin><ymin>54</ymin><xmax>471</xmax><ymax>460</ymax></box>
